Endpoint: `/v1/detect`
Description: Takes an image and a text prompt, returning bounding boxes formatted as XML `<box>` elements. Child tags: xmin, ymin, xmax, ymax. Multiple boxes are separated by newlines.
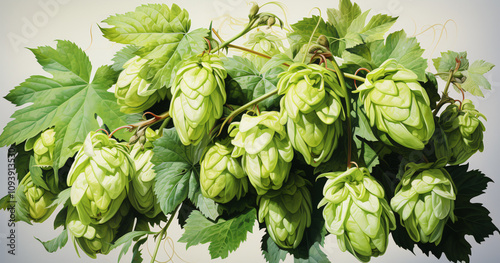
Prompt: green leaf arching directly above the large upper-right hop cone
<box><xmin>342</xmin><ymin>30</ymin><xmax>427</xmax><ymax>81</ymax></box>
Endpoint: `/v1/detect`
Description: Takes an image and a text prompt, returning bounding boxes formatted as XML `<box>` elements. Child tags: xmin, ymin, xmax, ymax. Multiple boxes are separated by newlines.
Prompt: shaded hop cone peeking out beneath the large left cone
<box><xmin>66</xmin><ymin>202</ymin><xmax>129</xmax><ymax>258</ymax></box>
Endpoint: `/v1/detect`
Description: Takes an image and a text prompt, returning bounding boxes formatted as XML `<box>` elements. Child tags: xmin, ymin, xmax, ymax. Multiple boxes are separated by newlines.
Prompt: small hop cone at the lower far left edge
<box><xmin>16</xmin><ymin>172</ymin><xmax>56</xmax><ymax>223</ymax></box>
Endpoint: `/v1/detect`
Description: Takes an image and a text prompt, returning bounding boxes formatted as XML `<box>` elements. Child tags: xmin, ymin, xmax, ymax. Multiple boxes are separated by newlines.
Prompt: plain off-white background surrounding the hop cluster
<box><xmin>0</xmin><ymin>0</ymin><xmax>500</xmax><ymax>263</ymax></box>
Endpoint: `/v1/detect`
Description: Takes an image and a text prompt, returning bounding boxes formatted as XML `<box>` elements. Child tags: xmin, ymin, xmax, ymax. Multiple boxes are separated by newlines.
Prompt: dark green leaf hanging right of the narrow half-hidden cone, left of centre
<box><xmin>151</xmin><ymin>128</ymin><xmax>218</xmax><ymax>219</ymax></box>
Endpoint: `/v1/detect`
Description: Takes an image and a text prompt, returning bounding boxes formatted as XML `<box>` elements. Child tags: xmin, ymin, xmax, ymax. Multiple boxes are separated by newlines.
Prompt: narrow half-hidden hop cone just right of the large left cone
<box><xmin>128</xmin><ymin>128</ymin><xmax>161</xmax><ymax>218</ymax></box>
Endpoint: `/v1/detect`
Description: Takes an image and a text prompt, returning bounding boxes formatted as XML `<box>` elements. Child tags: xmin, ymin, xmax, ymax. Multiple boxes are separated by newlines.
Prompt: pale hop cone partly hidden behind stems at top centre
<box><xmin>242</xmin><ymin>31</ymin><xmax>283</xmax><ymax>69</ymax></box>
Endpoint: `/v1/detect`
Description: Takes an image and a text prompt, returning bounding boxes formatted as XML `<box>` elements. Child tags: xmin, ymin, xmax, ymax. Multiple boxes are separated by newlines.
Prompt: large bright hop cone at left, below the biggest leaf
<box><xmin>67</xmin><ymin>132</ymin><xmax>135</xmax><ymax>224</ymax></box>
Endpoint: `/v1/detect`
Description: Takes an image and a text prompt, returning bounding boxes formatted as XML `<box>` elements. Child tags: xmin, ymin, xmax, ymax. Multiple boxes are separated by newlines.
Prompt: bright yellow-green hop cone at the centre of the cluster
<box><xmin>229</xmin><ymin>111</ymin><xmax>293</xmax><ymax>195</ymax></box>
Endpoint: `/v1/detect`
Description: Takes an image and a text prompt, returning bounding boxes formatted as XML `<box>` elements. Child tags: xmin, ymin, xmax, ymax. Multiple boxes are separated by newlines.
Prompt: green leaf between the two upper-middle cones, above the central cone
<box><xmin>224</xmin><ymin>56</ymin><xmax>284</xmax><ymax>110</ymax></box>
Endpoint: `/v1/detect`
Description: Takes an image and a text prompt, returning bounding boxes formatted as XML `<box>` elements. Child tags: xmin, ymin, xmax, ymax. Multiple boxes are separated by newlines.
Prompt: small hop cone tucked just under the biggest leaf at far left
<box><xmin>24</xmin><ymin>128</ymin><xmax>56</xmax><ymax>169</ymax></box>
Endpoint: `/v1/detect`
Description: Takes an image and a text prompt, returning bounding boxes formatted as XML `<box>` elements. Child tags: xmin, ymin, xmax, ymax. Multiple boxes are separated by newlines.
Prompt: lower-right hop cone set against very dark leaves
<box><xmin>391</xmin><ymin>164</ymin><xmax>456</xmax><ymax>245</ymax></box>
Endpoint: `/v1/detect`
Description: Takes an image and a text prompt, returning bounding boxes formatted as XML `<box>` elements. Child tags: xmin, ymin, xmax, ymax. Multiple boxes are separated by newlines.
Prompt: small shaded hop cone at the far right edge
<box><xmin>439</xmin><ymin>99</ymin><xmax>486</xmax><ymax>165</ymax></box>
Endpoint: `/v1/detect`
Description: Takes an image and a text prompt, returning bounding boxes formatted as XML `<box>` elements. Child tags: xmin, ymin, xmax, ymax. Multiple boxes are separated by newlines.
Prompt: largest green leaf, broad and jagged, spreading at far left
<box><xmin>0</xmin><ymin>41</ymin><xmax>132</xmax><ymax>168</ymax></box>
